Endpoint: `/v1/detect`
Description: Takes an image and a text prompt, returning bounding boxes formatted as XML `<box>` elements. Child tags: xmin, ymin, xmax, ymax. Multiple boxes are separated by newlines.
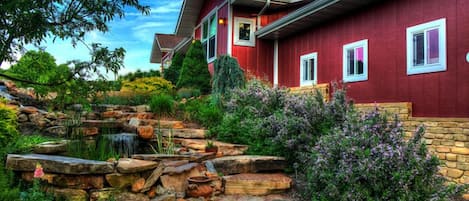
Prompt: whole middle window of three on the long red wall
<box><xmin>343</xmin><ymin>40</ymin><xmax>368</xmax><ymax>82</ymax></box>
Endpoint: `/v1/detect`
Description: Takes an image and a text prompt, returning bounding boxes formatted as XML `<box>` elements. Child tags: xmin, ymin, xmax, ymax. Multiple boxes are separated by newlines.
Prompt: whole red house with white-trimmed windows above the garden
<box><xmin>150</xmin><ymin>0</ymin><xmax>469</xmax><ymax>118</ymax></box>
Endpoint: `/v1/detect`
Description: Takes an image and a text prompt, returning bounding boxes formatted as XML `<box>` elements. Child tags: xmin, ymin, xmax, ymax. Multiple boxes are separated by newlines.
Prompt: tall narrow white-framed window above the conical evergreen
<box><xmin>201</xmin><ymin>13</ymin><xmax>217</xmax><ymax>62</ymax></box>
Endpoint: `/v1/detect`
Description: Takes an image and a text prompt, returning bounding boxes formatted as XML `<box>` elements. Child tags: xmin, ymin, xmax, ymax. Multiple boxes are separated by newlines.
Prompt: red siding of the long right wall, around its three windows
<box><xmin>279</xmin><ymin>0</ymin><xmax>469</xmax><ymax>117</ymax></box>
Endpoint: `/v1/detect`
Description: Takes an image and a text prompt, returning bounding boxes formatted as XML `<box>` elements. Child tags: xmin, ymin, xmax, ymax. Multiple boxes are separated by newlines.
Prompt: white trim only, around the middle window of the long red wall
<box><xmin>342</xmin><ymin>39</ymin><xmax>368</xmax><ymax>82</ymax></box>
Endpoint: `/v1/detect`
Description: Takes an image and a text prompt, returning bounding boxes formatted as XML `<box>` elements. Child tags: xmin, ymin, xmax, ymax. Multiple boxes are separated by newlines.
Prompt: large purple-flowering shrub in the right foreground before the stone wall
<box><xmin>305</xmin><ymin>109</ymin><xmax>463</xmax><ymax>201</ymax></box>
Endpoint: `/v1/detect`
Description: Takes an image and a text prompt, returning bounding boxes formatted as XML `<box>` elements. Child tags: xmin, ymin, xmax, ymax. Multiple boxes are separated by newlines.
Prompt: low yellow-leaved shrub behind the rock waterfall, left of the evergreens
<box><xmin>121</xmin><ymin>77</ymin><xmax>174</xmax><ymax>94</ymax></box>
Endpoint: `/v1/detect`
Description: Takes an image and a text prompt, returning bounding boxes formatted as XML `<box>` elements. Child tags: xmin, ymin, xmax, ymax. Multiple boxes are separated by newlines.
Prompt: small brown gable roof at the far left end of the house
<box><xmin>150</xmin><ymin>34</ymin><xmax>185</xmax><ymax>63</ymax></box>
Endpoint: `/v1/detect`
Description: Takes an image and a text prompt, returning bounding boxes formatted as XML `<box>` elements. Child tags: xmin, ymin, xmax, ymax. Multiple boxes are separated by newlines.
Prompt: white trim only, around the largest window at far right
<box><xmin>406</xmin><ymin>18</ymin><xmax>446</xmax><ymax>75</ymax></box>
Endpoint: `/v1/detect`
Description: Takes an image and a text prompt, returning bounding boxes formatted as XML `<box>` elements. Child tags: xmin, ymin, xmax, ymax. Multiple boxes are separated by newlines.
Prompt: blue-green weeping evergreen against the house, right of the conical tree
<box><xmin>212</xmin><ymin>55</ymin><xmax>245</xmax><ymax>94</ymax></box>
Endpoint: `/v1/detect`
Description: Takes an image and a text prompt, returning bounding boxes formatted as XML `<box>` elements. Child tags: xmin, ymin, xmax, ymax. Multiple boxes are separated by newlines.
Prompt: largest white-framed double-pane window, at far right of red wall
<box><xmin>407</xmin><ymin>18</ymin><xmax>446</xmax><ymax>75</ymax></box>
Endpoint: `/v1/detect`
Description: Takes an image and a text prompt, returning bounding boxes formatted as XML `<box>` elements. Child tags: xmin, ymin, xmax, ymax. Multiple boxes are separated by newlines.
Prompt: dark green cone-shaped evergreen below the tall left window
<box><xmin>176</xmin><ymin>40</ymin><xmax>211</xmax><ymax>94</ymax></box>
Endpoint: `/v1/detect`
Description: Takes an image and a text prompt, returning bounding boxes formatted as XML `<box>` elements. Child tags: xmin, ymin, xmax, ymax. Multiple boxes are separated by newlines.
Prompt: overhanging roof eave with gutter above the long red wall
<box><xmin>255</xmin><ymin>0</ymin><xmax>383</xmax><ymax>39</ymax></box>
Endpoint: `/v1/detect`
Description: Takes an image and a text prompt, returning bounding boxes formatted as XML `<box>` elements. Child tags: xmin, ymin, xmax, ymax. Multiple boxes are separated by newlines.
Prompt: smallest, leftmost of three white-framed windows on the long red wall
<box><xmin>300</xmin><ymin>52</ymin><xmax>318</xmax><ymax>86</ymax></box>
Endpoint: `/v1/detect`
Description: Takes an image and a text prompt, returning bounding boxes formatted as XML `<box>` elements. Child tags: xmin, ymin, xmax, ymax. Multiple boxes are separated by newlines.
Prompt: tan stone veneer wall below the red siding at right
<box><xmin>355</xmin><ymin>102</ymin><xmax>469</xmax><ymax>184</ymax></box>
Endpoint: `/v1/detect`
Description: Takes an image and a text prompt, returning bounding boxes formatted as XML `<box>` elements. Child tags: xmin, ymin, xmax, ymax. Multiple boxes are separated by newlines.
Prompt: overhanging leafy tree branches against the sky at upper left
<box><xmin>0</xmin><ymin>0</ymin><xmax>149</xmax><ymax>85</ymax></box>
